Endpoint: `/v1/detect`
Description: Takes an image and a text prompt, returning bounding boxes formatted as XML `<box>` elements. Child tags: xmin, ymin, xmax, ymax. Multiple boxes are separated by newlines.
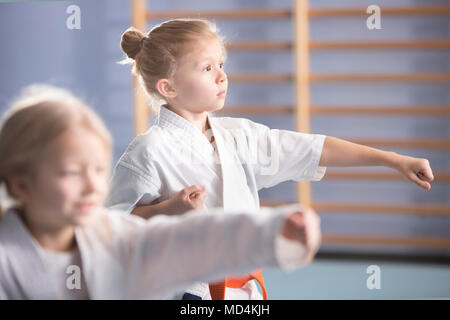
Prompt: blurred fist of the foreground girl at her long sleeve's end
<box><xmin>282</xmin><ymin>209</ymin><xmax>322</xmax><ymax>262</ymax></box>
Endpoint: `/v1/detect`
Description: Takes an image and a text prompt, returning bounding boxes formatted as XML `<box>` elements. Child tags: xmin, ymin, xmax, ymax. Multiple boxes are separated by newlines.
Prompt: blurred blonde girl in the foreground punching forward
<box><xmin>0</xmin><ymin>86</ymin><xmax>320</xmax><ymax>299</ymax></box>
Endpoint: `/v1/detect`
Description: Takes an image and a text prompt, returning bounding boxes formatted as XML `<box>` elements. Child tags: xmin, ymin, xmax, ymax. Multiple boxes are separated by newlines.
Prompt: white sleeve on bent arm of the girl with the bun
<box><xmin>105</xmin><ymin>161</ymin><xmax>161</xmax><ymax>213</ymax></box>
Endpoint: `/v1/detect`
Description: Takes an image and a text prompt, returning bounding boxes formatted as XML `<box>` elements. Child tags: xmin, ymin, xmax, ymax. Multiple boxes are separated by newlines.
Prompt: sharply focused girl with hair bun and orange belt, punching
<box><xmin>107</xmin><ymin>19</ymin><xmax>433</xmax><ymax>299</ymax></box>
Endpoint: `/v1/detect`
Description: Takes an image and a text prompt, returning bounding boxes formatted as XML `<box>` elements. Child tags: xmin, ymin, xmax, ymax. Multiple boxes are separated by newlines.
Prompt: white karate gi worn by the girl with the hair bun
<box><xmin>106</xmin><ymin>106</ymin><xmax>326</xmax><ymax>299</ymax></box>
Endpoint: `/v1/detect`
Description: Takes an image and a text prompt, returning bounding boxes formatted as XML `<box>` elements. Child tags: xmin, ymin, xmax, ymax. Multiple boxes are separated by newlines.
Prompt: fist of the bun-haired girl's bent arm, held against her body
<box><xmin>168</xmin><ymin>185</ymin><xmax>206</xmax><ymax>214</ymax></box>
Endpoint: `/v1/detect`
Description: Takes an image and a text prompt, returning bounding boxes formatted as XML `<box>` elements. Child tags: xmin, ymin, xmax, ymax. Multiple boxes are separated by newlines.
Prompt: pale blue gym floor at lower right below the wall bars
<box><xmin>264</xmin><ymin>257</ymin><xmax>450</xmax><ymax>300</ymax></box>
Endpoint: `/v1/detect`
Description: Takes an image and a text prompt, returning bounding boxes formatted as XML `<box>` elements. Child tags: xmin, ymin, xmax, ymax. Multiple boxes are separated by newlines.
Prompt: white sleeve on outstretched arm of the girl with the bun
<box><xmin>248</xmin><ymin>121</ymin><xmax>326</xmax><ymax>190</ymax></box>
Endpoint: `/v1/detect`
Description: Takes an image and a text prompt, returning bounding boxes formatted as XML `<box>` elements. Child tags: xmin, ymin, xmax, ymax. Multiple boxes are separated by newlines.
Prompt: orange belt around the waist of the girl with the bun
<box><xmin>209</xmin><ymin>269</ymin><xmax>267</xmax><ymax>300</ymax></box>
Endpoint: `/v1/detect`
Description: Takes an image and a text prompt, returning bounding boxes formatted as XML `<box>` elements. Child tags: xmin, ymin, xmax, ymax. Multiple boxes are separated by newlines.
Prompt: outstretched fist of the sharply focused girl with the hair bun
<box><xmin>395</xmin><ymin>155</ymin><xmax>434</xmax><ymax>190</ymax></box>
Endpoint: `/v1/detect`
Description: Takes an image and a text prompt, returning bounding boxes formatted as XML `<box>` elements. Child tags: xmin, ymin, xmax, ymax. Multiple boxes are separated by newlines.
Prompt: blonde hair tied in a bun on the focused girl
<box><xmin>120</xmin><ymin>19</ymin><xmax>226</xmax><ymax>113</ymax></box>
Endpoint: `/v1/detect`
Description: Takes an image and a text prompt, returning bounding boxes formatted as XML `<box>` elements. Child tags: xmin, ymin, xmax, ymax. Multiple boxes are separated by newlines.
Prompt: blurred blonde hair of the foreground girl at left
<box><xmin>0</xmin><ymin>85</ymin><xmax>112</xmax><ymax>216</ymax></box>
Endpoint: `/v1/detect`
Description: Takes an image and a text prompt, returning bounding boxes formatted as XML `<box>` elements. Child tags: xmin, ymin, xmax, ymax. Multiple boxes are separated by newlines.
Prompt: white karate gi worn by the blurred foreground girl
<box><xmin>0</xmin><ymin>206</ymin><xmax>314</xmax><ymax>299</ymax></box>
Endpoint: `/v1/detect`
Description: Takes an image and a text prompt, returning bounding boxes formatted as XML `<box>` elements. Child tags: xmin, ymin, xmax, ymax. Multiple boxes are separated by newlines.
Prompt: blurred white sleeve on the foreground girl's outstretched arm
<box><xmin>119</xmin><ymin>205</ymin><xmax>298</xmax><ymax>299</ymax></box>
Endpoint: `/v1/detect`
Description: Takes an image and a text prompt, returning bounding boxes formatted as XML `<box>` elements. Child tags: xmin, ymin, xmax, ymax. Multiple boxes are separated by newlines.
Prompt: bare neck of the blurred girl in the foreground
<box><xmin>20</xmin><ymin>212</ymin><xmax>76</xmax><ymax>252</ymax></box>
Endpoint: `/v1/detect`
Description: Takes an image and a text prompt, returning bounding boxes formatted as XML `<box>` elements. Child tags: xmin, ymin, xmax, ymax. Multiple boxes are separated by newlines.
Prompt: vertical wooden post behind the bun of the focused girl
<box><xmin>132</xmin><ymin>0</ymin><xmax>149</xmax><ymax>135</ymax></box>
